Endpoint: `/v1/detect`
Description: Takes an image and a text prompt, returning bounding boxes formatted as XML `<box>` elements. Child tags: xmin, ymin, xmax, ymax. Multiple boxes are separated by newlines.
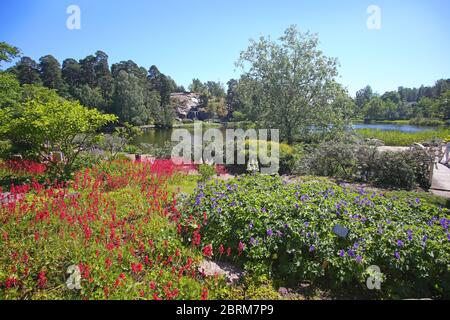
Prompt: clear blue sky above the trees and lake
<box><xmin>0</xmin><ymin>0</ymin><xmax>450</xmax><ymax>94</ymax></box>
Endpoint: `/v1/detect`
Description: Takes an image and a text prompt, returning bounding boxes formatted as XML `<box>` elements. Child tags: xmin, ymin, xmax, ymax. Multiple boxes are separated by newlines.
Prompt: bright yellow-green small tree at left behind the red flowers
<box><xmin>0</xmin><ymin>89</ymin><xmax>116</xmax><ymax>175</ymax></box>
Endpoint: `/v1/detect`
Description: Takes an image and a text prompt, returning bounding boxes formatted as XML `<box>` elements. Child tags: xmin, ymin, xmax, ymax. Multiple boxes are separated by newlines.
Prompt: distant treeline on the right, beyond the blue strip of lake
<box><xmin>355</xmin><ymin>79</ymin><xmax>450</xmax><ymax>123</ymax></box>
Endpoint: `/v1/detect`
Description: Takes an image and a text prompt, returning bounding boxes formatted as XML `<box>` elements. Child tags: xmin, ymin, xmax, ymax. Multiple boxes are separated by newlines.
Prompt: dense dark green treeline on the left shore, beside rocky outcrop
<box><xmin>3</xmin><ymin>51</ymin><xmax>182</xmax><ymax>126</ymax></box>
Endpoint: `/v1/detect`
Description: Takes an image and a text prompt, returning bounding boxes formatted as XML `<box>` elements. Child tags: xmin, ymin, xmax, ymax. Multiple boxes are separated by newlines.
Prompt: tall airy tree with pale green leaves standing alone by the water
<box><xmin>237</xmin><ymin>26</ymin><xmax>343</xmax><ymax>144</ymax></box>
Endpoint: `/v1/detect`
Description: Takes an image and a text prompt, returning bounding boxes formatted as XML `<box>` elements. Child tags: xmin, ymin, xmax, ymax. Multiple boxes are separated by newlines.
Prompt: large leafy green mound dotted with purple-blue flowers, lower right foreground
<box><xmin>182</xmin><ymin>175</ymin><xmax>450</xmax><ymax>297</ymax></box>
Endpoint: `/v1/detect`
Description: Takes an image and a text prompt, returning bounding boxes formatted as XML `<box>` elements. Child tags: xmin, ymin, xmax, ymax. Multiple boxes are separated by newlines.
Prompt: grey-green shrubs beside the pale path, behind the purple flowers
<box><xmin>295</xmin><ymin>139</ymin><xmax>433</xmax><ymax>190</ymax></box>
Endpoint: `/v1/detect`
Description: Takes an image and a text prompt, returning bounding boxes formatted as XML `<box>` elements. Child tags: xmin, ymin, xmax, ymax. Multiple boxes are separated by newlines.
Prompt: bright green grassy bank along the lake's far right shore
<box><xmin>356</xmin><ymin>128</ymin><xmax>450</xmax><ymax>146</ymax></box>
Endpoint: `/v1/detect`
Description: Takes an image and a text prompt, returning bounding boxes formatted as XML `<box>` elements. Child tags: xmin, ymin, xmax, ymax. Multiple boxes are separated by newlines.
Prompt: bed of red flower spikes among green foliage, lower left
<box><xmin>0</xmin><ymin>160</ymin><xmax>224</xmax><ymax>299</ymax></box>
